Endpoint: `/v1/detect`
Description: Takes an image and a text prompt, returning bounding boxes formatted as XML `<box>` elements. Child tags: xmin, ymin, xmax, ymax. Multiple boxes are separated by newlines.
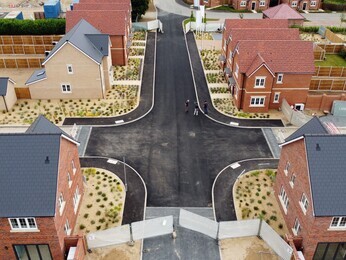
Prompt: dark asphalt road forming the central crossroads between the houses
<box><xmin>86</xmin><ymin>12</ymin><xmax>271</xmax><ymax>207</ymax></box>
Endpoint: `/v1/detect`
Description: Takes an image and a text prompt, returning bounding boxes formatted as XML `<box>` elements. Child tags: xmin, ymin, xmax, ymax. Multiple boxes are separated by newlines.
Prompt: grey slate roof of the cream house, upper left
<box><xmin>43</xmin><ymin>19</ymin><xmax>109</xmax><ymax>64</ymax></box>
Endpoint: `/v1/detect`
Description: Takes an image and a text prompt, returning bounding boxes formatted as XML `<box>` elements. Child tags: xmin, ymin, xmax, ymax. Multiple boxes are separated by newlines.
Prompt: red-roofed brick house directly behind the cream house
<box><xmin>66</xmin><ymin>0</ymin><xmax>132</xmax><ymax>65</ymax></box>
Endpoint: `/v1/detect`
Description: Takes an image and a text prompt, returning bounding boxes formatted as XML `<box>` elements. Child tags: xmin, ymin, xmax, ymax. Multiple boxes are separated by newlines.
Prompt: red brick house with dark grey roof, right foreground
<box><xmin>274</xmin><ymin>117</ymin><xmax>346</xmax><ymax>260</ymax></box>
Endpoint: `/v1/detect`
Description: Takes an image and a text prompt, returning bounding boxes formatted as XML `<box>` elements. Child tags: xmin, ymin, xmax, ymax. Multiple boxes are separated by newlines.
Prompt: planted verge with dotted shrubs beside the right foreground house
<box><xmin>233</xmin><ymin>170</ymin><xmax>288</xmax><ymax>236</ymax></box>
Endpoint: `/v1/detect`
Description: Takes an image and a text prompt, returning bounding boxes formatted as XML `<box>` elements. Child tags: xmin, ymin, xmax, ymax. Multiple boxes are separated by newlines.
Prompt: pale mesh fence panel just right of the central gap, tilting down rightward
<box><xmin>179</xmin><ymin>209</ymin><xmax>218</xmax><ymax>239</ymax></box>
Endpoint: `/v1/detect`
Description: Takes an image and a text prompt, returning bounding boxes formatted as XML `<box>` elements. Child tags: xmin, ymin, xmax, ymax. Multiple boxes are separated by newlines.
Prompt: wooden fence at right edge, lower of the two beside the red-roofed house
<box><xmin>309</xmin><ymin>78</ymin><xmax>346</xmax><ymax>92</ymax></box>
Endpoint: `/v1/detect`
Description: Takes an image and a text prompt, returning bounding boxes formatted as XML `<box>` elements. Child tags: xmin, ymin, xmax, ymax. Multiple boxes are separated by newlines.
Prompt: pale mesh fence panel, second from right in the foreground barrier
<box><xmin>219</xmin><ymin>219</ymin><xmax>260</xmax><ymax>239</ymax></box>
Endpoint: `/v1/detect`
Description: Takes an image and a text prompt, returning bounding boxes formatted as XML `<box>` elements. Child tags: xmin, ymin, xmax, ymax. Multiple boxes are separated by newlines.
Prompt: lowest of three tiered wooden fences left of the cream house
<box><xmin>0</xmin><ymin>55</ymin><xmax>44</xmax><ymax>69</ymax></box>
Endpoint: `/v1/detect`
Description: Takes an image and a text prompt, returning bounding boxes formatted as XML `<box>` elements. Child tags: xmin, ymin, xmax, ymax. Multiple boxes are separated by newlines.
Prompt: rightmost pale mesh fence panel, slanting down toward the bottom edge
<box><xmin>260</xmin><ymin>221</ymin><xmax>293</xmax><ymax>260</ymax></box>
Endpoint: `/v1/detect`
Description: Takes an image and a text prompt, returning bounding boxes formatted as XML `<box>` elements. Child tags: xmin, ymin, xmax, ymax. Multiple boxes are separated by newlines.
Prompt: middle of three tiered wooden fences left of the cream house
<box><xmin>0</xmin><ymin>44</ymin><xmax>54</xmax><ymax>54</ymax></box>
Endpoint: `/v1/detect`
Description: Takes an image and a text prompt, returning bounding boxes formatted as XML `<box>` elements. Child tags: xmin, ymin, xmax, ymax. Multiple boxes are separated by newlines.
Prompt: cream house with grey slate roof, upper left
<box><xmin>25</xmin><ymin>19</ymin><xmax>112</xmax><ymax>99</ymax></box>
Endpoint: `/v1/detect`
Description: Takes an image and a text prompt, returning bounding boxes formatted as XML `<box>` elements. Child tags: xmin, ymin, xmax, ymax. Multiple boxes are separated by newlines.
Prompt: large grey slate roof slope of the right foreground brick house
<box><xmin>305</xmin><ymin>134</ymin><xmax>346</xmax><ymax>216</ymax></box>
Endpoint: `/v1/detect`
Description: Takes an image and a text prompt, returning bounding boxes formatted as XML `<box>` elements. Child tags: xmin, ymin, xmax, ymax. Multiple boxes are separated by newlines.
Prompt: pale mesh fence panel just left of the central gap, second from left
<box><xmin>131</xmin><ymin>216</ymin><xmax>173</xmax><ymax>240</ymax></box>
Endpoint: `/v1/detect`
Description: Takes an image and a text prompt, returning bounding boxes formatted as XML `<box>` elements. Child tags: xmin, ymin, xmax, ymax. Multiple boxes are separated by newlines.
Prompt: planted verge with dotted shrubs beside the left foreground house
<box><xmin>74</xmin><ymin>168</ymin><xmax>125</xmax><ymax>233</ymax></box>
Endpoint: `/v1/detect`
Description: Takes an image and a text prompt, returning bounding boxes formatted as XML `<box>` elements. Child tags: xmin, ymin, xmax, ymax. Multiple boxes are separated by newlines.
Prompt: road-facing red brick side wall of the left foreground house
<box><xmin>54</xmin><ymin>138</ymin><xmax>84</xmax><ymax>254</ymax></box>
